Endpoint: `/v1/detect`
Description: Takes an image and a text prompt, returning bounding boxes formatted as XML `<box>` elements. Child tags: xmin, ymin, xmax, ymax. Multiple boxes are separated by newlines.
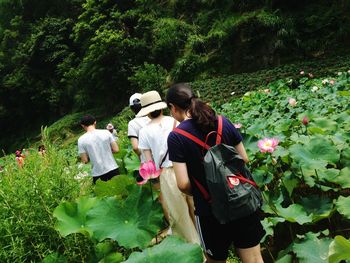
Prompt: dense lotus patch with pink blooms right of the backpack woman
<box><xmin>220</xmin><ymin>70</ymin><xmax>350</xmax><ymax>262</ymax></box>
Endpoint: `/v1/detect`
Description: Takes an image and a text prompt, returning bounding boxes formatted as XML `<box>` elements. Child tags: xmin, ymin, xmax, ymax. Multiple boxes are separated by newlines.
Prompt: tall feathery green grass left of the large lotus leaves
<box><xmin>0</xmin><ymin>135</ymin><xmax>91</xmax><ymax>262</ymax></box>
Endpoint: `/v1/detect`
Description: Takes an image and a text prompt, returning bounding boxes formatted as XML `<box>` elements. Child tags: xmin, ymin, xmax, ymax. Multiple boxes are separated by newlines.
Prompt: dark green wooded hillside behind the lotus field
<box><xmin>0</xmin><ymin>0</ymin><xmax>350</xmax><ymax>152</ymax></box>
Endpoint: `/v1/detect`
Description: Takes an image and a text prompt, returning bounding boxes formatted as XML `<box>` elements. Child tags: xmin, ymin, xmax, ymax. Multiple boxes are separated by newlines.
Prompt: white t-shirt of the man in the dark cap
<box><xmin>78</xmin><ymin>129</ymin><xmax>118</xmax><ymax>176</ymax></box>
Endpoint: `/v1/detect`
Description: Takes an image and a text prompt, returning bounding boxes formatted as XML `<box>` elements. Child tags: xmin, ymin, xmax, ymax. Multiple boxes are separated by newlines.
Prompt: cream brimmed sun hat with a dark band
<box><xmin>136</xmin><ymin>90</ymin><xmax>167</xmax><ymax>117</ymax></box>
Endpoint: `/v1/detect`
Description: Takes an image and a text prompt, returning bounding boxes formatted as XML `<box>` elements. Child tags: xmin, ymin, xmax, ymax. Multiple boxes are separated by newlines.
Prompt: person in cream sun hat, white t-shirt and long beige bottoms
<box><xmin>136</xmin><ymin>91</ymin><xmax>199</xmax><ymax>244</ymax></box>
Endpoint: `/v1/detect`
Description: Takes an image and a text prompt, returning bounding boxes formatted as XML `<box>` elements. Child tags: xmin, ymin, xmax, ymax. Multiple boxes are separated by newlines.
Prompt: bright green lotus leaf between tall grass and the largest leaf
<box><xmin>53</xmin><ymin>197</ymin><xmax>98</xmax><ymax>236</ymax></box>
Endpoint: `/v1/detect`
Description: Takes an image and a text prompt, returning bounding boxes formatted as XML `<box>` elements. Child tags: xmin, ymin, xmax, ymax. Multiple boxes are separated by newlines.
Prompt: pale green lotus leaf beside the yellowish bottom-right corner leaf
<box><xmin>293</xmin><ymin>232</ymin><xmax>332</xmax><ymax>263</ymax></box>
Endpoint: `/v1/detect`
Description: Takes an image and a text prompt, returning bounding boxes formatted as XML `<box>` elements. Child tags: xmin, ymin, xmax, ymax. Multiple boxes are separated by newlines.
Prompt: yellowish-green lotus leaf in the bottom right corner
<box><xmin>328</xmin><ymin>236</ymin><xmax>350</xmax><ymax>263</ymax></box>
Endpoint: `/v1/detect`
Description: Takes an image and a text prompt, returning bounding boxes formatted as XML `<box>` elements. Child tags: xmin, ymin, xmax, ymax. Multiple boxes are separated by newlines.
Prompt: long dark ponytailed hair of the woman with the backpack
<box><xmin>166</xmin><ymin>83</ymin><xmax>216</xmax><ymax>132</ymax></box>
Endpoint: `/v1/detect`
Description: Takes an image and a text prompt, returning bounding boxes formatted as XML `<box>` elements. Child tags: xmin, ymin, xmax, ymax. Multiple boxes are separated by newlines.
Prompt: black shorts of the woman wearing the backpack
<box><xmin>196</xmin><ymin>212</ymin><xmax>265</xmax><ymax>260</ymax></box>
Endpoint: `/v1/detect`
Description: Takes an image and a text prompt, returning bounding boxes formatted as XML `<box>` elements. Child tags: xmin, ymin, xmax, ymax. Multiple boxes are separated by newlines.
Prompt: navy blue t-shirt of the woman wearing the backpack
<box><xmin>168</xmin><ymin>117</ymin><xmax>242</xmax><ymax>216</ymax></box>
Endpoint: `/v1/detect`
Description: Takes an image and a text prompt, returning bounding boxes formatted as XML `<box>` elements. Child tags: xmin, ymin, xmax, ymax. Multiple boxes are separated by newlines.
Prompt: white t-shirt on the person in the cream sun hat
<box><xmin>139</xmin><ymin>116</ymin><xmax>175</xmax><ymax>169</ymax></box>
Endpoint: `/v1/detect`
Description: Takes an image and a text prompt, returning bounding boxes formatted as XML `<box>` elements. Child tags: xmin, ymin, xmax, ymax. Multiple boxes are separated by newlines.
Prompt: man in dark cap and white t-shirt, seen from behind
<box><xmin>78</xmin><ymin>115</ymin><xmax>119</xmax><ymax>184</ymax></box>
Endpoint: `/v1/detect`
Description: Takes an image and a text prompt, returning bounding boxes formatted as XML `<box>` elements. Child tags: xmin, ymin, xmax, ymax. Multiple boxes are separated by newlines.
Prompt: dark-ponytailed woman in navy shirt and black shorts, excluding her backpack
<box><xmin>166</xmin><ymin>83</ymin><xmax>265</xmax><ymax>263</ymax></box>
